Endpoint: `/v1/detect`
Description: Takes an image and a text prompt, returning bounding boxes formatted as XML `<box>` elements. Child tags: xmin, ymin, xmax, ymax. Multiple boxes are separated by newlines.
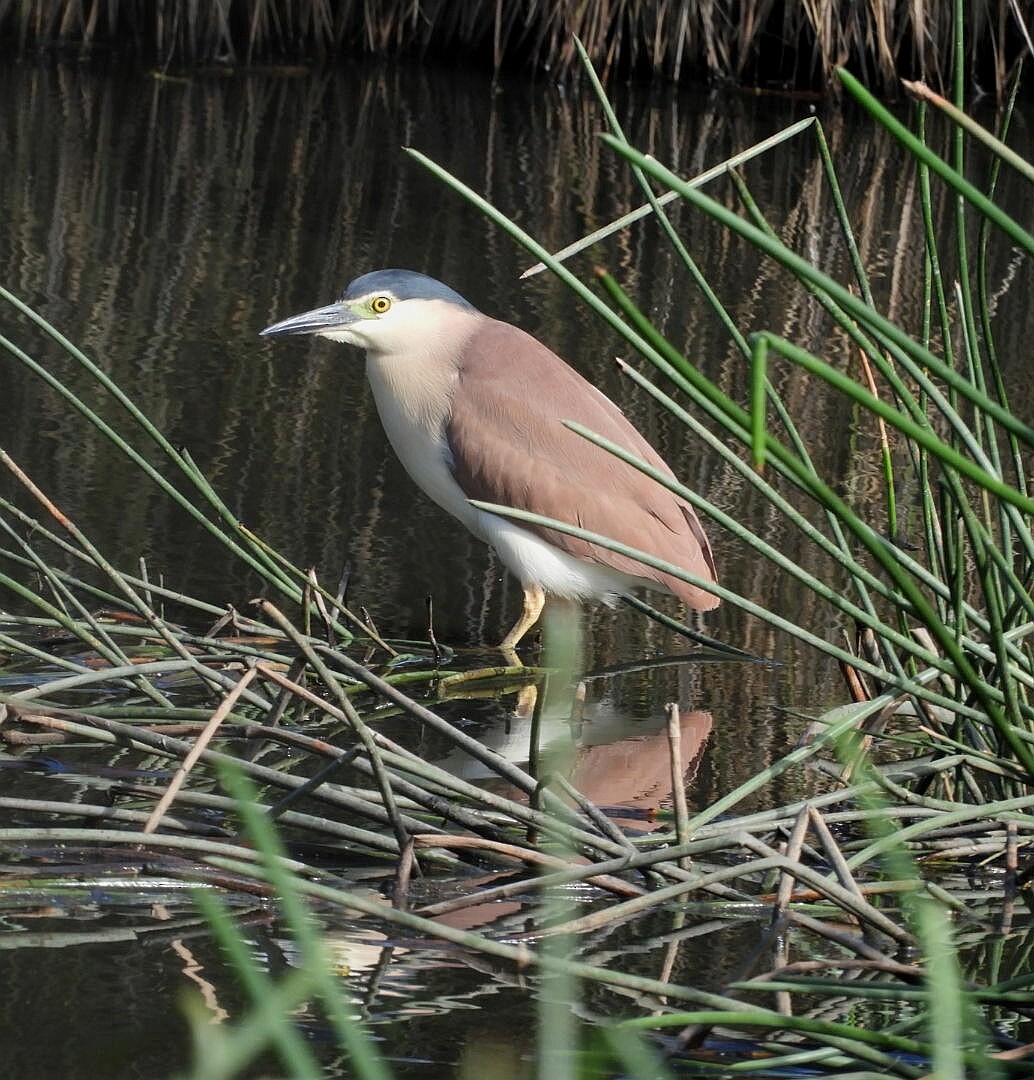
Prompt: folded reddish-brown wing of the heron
<box><xmin>446</xmin><ymin>319</ymin><xmax>717</xmax><ymax>610</ymax></box>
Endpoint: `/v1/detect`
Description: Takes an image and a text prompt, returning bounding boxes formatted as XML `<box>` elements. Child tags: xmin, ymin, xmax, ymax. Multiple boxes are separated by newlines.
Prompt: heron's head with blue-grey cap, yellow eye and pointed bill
<box><xmin>261</xmin><ymin>270</ymin><xmax>479</xmax><ymax>353</ymax></box>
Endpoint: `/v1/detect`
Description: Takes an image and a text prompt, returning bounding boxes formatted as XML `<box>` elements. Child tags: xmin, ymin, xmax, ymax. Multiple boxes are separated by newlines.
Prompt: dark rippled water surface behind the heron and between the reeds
<box><xmin>0</xmin><ymin>65</ymin><xmax>1034</xmax><ymax>1077</ymax></box>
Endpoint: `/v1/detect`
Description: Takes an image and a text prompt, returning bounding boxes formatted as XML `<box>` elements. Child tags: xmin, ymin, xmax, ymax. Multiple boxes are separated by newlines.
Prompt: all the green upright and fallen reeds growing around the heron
<box><xmin>0</xmin><ymin>3</ymin><xmax>1034</xmax><ymax>1080</ymax></box>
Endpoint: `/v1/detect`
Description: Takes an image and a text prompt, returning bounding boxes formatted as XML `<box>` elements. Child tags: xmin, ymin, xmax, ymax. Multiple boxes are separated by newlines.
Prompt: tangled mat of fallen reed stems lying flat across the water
<box><xmin>0</xmin><ymin>602</ymin><xmax>1034</xmax><ymax>1077</ymax></box>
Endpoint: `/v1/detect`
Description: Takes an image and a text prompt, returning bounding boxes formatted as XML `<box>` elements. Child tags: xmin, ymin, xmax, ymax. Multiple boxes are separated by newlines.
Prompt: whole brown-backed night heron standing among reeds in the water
<box><xmin>263</xmin><ymin>270</ymin><xmax>719</xmax><ymax>651</ymax></box>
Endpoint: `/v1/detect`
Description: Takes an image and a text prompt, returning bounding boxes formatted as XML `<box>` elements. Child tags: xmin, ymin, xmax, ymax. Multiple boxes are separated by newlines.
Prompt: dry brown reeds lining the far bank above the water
<box><xmin>0</xmin><ymin>0</ymin><xmax>1022</xmax><ymax>90</ymax></box>
